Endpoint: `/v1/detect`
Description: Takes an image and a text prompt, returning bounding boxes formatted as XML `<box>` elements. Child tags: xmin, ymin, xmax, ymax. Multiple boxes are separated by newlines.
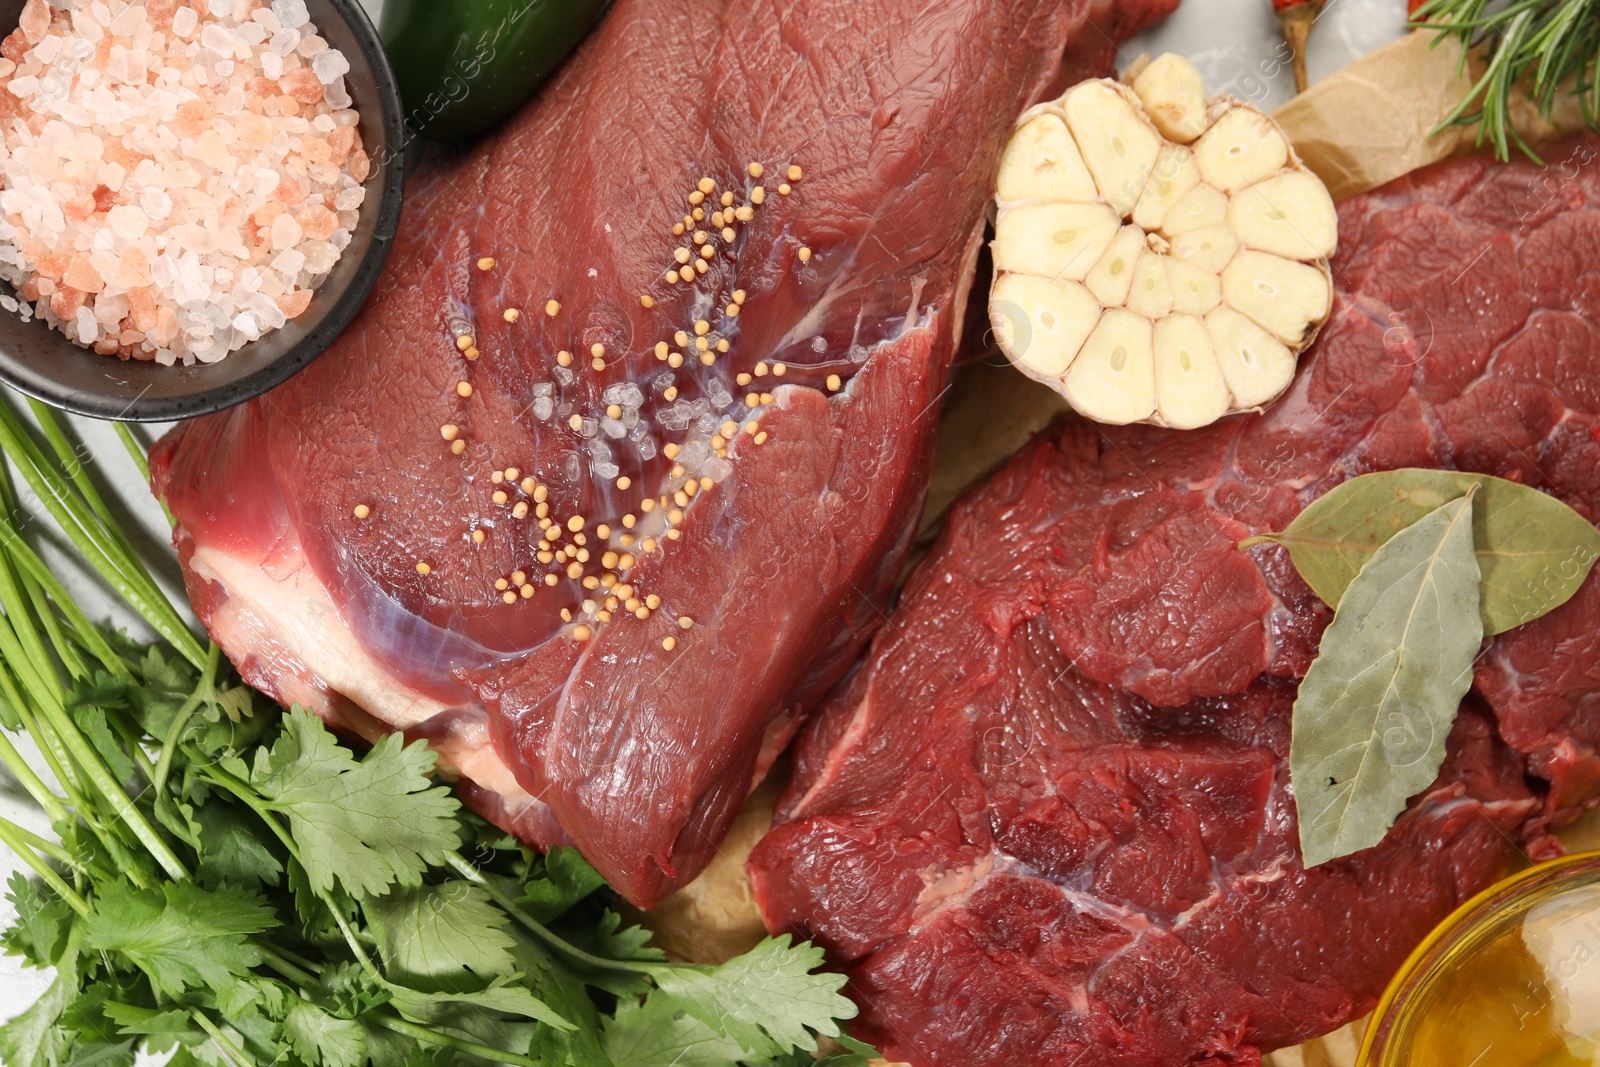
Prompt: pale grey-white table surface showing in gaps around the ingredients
<box><xmin>0</xmin><ymin>0</ymin><xmax>1405</xmax><ymax>1043</ymax></box>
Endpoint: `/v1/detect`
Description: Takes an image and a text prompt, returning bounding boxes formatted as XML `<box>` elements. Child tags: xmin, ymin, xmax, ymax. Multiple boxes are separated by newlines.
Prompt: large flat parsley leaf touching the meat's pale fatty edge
<box><xmin>250</xmin><ymin>709</ymin><xmax>461</xmax><ymax>897</ymax></box>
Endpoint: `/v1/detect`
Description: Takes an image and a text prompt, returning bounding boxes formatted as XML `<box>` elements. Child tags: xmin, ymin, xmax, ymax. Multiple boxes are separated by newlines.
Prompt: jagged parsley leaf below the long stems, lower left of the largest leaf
<box><xmin>85</xmin><ymin>881</ymin><xmax>278</xmax><ymax>997</ymax></box>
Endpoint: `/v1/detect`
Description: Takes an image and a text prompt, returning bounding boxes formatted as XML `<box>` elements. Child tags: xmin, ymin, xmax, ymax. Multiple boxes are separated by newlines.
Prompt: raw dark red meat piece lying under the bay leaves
<box><xmin>750</xmin><ymin>138</ymin><xmax>1600</xmax><ymax>1067</ymax></box>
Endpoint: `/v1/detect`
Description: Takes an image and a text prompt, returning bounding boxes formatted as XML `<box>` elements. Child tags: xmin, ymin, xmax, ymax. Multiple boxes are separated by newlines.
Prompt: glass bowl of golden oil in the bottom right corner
<box><xmin>1358</xmin><ymin>851</ymin><xmax>1600</xmax><ymax>1067</ymax></box>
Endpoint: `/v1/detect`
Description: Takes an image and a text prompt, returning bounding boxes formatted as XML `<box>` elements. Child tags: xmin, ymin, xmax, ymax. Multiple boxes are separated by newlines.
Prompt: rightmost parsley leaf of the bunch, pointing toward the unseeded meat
<box><xmin>651</xmin><ymin>934</ymin><xmax>856</xmax><ymax>1056</ymax></box>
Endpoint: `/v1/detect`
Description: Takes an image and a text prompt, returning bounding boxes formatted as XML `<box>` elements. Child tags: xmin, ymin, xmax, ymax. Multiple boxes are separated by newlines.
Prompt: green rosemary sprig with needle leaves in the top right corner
<box><xmin>1411</xmin><ymin>0</ymin><xmax>1600</xmax><ymax>166</ymax></box>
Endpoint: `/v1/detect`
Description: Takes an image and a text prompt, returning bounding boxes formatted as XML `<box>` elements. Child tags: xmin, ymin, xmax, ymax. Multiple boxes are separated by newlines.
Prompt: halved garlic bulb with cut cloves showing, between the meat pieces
<box><xmin>989</xmin><ymin>54</ymin><xmax>1339</xmax><ymax>429</ymax></box>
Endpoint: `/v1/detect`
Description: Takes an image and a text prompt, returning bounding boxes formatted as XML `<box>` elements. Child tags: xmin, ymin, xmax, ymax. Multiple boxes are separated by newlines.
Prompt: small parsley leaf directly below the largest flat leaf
<box><xmin>362</xmin><ymin>880</ymin><xmax>517</xmax><ymax>992</ymax></box>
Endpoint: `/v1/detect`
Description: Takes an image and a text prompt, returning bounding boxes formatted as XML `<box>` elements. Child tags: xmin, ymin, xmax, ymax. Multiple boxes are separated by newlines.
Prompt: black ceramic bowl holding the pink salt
<box><xmin>0</xmin><ymin>0</ymin><xmax>405</xmax><ymax>422</ymax></box>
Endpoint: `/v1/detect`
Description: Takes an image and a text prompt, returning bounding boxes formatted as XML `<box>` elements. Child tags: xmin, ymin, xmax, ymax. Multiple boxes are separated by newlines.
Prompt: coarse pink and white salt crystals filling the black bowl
<box><xmin>0</xmin><ymin>0</ymin><xmax>371</xmax><ymax>365</ymax></box>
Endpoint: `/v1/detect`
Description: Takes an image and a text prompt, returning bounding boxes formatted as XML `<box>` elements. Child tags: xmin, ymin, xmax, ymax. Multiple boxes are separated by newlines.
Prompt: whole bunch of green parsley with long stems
<box><xmin>0</xmin><ymin>400</ymin><xmax>870</xmax><ymax>1067</ymax></box>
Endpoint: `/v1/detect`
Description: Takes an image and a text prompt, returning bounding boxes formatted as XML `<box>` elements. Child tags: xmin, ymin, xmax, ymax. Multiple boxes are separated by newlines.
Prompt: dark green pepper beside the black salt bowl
<box><xmin>382</xmin><ymin>0</ymin><xmax>606</xmax><ymax>141</ymax></box>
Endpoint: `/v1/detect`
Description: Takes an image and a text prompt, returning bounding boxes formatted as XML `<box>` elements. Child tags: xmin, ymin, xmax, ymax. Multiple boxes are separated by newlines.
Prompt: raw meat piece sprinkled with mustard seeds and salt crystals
<box><xmin>154</xmin><ymin>0</ymin><xmax>1176</xmax><ymax>905</ymax></box>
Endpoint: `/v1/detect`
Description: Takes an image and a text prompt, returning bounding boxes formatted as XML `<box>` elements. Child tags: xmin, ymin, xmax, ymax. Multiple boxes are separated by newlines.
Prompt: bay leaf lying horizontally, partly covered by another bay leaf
<box><xmin>1242</xmin><ymin>467</ymin><xmax>1600</xmax><ymax>633</ymax></box>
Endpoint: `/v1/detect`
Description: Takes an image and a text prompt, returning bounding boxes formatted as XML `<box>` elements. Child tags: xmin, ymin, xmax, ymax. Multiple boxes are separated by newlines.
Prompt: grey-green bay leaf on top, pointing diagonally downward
<box><xmin>1290</xmin><ymin>488</ymin><xmax>1483</xmax><ymax>867</ymax></box>
